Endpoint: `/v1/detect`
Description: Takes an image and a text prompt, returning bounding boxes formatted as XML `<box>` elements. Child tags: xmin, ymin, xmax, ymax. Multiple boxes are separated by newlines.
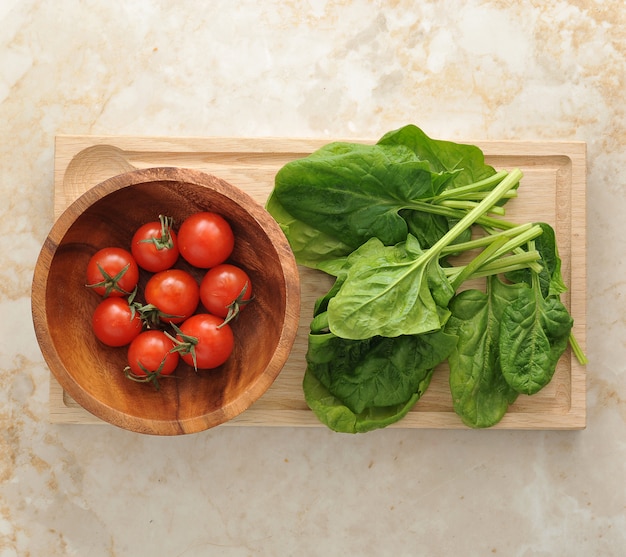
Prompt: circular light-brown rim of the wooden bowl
<box><xmin>31</xmin><ymin>167</ymin><xmax>300</xmax><ymax>435</ymax></box>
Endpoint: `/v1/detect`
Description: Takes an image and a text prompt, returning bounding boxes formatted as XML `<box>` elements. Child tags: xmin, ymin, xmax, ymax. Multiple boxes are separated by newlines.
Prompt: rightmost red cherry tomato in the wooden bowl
<box><xmin>200</xmin><ymin>263</ymin><xmax>252</xmax><ymax>321</ymax></box>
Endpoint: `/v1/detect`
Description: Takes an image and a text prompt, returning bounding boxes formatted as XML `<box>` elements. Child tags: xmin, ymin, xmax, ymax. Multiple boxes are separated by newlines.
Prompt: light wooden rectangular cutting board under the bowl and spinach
<box><xmin>50</xmin><ymin>135</ymin><xmax>586</xmax><ymax>429</ymax></box>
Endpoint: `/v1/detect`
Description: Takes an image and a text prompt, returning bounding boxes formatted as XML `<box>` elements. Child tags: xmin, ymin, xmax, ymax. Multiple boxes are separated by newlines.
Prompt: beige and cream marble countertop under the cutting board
<box><xmin>0</xmin><ymin>0</ymin><xmax>626</xmax><ymax>557</ymax></box>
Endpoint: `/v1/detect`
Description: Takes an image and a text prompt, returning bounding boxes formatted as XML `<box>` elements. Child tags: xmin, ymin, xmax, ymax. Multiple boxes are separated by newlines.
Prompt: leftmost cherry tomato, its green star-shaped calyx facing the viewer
<box><xmin>87</xmin><ymin>247</ymin><xmax>139</xmax><ymax>297</ymax></box>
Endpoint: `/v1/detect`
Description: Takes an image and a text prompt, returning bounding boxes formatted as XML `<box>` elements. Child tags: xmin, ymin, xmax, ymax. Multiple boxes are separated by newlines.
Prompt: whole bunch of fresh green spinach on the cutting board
<box><xmin>267</xmin><ymin>126</ymin><xmax>584</xmax><ymax>433</ymax></box>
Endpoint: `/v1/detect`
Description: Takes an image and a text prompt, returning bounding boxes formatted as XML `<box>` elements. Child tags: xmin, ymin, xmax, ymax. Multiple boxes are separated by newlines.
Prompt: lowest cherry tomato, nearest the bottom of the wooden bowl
<box><xmin>128</xmin><ymin>329</ymin><xmax>180</xmax><ymax>378</ymax></box>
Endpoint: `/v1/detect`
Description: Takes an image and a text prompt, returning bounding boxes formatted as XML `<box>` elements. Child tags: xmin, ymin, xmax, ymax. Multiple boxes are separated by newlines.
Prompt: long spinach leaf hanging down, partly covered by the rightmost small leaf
<box><xmin>445</xmin><ymin>276</ymin><xmax>529</xmax><ymax>428</ymax></box>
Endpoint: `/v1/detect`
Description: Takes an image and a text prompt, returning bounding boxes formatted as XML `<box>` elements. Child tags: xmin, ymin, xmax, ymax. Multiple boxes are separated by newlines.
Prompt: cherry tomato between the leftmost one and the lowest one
<box><xmin>91</xmin><ymin>297</ymin><xmax>143</xmax><ymax>346</ymax></box>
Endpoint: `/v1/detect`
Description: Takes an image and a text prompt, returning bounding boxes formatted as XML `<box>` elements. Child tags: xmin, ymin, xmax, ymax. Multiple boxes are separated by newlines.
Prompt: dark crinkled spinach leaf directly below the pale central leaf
<box><xmin>306</xmin><ymin>331</ymin><xmax>456</xmax><ymax>414</ymax></box>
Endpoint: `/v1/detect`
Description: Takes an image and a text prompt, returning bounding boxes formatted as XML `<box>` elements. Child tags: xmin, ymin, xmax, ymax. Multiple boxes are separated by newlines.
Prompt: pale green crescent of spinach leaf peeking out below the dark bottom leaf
<box><xmin>302</xmin><ymin>369</ymin><xmax>420</xmax><ymax>433</ymax></box>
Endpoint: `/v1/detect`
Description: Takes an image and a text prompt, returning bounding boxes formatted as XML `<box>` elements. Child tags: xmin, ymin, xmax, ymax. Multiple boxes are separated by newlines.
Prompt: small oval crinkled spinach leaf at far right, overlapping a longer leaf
<box><xmin>499</xmin><ymin>275</ymin><xmax>574</xmax><ymax>395</ymax></box>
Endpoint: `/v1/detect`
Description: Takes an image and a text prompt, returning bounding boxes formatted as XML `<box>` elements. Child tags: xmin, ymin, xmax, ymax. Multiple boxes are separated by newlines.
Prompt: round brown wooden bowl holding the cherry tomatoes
<box><xmin>32</xmin><ymin>168</ymin><xmax>300</xmax><ymax>435</ymax></box>
